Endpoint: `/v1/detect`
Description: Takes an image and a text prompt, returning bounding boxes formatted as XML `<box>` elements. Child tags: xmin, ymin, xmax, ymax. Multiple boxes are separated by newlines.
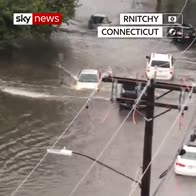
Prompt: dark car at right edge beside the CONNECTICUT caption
<box><xmin>167</xmin><ymin>24</ymin><xmax>196</xmax><ymax>43</ymax></box>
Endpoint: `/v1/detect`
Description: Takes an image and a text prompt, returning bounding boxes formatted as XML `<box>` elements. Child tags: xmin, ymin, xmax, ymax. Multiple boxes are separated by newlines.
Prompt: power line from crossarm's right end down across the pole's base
<box><xmin>129</xmin><ymin>85</ymin><xmax>195</xmax><ymax>196</ymax></box>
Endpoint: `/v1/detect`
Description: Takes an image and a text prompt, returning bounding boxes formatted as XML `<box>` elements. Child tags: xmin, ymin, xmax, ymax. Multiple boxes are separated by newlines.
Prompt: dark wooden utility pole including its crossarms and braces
<box><xmin>103</xmin><ymin>76</ymin><xmax>196</xmax><ymax>196</ymax></box>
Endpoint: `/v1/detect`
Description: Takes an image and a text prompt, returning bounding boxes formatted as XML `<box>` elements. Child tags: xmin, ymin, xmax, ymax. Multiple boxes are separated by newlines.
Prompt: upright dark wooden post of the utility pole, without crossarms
<box><xmin>141</xmin><ymin>80</ymin><xmax>155</xmax><ymax>196</ymax></box>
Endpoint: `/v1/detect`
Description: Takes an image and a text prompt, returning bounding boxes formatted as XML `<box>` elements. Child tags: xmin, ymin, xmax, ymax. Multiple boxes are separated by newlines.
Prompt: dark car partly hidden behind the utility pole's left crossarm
<box><xmin>116</xmin><ymin>83</ymin><xmax>146</xmax><ymax>110</ymax></box>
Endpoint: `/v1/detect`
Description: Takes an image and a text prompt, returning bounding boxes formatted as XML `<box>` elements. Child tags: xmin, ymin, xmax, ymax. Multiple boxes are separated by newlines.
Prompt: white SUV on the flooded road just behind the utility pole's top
<box><xmin>146</xmin><ymin>53</ymin><xmax>174</xmax><ymax>80</ymax></box>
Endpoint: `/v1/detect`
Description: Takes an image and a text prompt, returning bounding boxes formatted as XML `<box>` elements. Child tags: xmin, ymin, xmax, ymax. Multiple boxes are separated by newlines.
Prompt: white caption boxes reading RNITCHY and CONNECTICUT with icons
<box><xmin>97</xmin><ymin>13</ymin><xmax>183</xmax><ymax>38</ymax></box>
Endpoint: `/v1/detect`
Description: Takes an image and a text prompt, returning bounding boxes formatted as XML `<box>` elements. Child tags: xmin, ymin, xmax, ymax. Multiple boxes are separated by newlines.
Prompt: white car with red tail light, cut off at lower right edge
<box><xmin>174</xmin><ymin>145</ymin><xmax>196</xmax><ymax>176</ymax></box>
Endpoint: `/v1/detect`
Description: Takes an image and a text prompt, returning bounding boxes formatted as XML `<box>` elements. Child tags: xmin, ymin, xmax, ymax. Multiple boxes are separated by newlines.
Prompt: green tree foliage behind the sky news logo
<box><xmin>0</xmin><ymin>0</ymin><xmax>78</xmax><ymax>43</ymax></box>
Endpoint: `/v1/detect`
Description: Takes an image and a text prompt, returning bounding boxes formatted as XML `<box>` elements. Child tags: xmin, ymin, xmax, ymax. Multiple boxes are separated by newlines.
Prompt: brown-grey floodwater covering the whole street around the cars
<box><xmin>0</xmin><ymin>0</ymin><xmax>196</xmax><ymax>196</ymax></box>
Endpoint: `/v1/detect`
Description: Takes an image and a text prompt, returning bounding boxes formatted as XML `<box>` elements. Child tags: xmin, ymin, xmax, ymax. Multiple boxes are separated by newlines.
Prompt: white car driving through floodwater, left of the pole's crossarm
<box><xmin>76</xmin><ymin>69</ymin><xmax>101</xmax><ymax>90</ymax></box>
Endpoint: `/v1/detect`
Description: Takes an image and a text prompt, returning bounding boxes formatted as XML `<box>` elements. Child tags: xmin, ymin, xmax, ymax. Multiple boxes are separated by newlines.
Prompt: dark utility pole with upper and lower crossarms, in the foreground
<box><xmin>103</xmin><ymin>76</ymin><xmax>196</xmax><ymax>196</ymax></box>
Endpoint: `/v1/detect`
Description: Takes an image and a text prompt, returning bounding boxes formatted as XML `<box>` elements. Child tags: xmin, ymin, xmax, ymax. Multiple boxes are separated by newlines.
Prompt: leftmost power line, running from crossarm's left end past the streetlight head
<box><xmin>11</xmin><ymin>77</ymin><xmax>102</xmax><ymax>196</ymax></box>
